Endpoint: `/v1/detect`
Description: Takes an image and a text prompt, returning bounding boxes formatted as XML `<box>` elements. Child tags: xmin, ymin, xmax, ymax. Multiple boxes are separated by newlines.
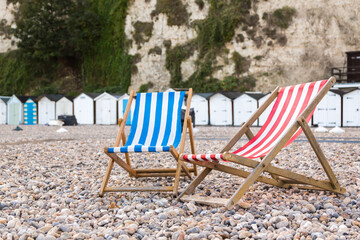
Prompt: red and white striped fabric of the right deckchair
<box><xmin>183</xmin><ymin>80</ymin><xmax>327</xmax><ymax>162</ymax></box>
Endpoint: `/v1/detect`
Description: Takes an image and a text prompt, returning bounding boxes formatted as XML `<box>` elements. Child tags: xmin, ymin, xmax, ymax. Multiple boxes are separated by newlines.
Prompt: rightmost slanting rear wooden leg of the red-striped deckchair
<box><xmin>298</xmin><ymin>117</ymin><xmax>340</xmax><ymax>189</ymax></box>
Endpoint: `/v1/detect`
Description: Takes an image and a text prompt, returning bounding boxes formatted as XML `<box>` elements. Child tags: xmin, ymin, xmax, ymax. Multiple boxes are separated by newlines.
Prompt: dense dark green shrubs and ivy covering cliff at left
<box><xmin>0</xmin><ymin>0</ymin><xmax>132</xmax><ymax>95</ymax></box>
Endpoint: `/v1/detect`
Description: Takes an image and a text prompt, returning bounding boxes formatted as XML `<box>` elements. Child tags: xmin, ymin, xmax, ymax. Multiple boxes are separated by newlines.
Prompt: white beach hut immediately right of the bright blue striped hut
<box><xmin>37</xmin><ymin>94</ymin><xmax>63</xmax><ymax>124</ymax></box>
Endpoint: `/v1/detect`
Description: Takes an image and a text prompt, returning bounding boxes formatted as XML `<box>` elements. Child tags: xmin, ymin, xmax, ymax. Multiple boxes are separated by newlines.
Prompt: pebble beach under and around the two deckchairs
<box><xmin>0</xmin><ymin>125</ymin><xmax>360</xmax><ymax>240</ymax></box>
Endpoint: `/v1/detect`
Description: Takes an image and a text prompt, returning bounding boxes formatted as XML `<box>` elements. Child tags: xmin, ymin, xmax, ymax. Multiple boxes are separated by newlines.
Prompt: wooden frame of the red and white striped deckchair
<box><xmin>178</xmin><ymin>77</ymin><xmax>346</xmax><ymax>209</ymax></box>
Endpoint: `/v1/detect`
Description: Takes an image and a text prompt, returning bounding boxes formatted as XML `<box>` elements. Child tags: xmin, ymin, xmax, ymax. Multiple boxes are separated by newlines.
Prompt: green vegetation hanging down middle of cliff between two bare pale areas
<box><xmin>166</xmin><ymin>0</ymin><xmax>259</xmax><ymax>92</ymax></box>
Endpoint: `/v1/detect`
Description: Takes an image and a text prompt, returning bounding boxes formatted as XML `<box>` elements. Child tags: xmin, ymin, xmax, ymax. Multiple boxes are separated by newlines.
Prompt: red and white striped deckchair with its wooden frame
<box><xmin>178</xmin><ymin>77</ymin><xmax>346</xmax><ymax>209</ymax></box>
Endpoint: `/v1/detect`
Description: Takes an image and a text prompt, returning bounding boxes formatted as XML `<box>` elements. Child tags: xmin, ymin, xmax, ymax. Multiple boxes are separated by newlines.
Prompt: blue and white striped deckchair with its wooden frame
<box><xmin>100</xmin><ymin>89</ymin><xmax>196</xmax><ymax>196</ymax></box>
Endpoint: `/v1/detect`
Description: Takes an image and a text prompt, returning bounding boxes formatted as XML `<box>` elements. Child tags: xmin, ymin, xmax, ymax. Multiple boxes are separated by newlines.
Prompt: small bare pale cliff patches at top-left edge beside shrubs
<box><xmin>0</xmin><ymin>0</ymin><xmax>16</xmax><ymax>52</ymax></box>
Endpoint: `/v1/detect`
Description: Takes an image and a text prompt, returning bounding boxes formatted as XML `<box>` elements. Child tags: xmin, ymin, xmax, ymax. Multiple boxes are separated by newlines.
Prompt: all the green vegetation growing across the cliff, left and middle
<box><xmin>0</xmin><ymin>0</ymin><xmax>296</xmax><ymax>95</ymax></box>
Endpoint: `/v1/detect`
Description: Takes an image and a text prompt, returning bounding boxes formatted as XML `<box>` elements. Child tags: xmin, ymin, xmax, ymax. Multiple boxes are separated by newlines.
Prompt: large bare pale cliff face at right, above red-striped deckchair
<box><xmin>236</xmin><ymin>0</ymin><xmax>360</xmax><ymax>91</ymax></box>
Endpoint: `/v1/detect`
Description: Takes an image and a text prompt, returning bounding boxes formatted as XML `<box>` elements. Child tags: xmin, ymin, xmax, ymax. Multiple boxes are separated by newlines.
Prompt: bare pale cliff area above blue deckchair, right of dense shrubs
<box><xmin>125</xmin><ymin>0</ymin><xmax>209</xmax><ymax>91</ymax></box>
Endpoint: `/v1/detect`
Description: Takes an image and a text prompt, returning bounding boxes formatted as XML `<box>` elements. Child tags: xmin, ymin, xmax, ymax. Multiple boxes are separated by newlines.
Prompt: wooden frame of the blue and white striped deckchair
<box><xmin>100</xmin><ymin>88</ymin><xmax>197</xmax><ymax>196</ymax></box>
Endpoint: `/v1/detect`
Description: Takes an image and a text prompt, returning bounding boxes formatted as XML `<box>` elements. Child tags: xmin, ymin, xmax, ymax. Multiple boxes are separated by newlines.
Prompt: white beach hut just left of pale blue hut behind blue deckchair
<box><xmin>94</xmin><ymin>92</ymin><xmax>121</xmax><ymax>125</ymax></box>
